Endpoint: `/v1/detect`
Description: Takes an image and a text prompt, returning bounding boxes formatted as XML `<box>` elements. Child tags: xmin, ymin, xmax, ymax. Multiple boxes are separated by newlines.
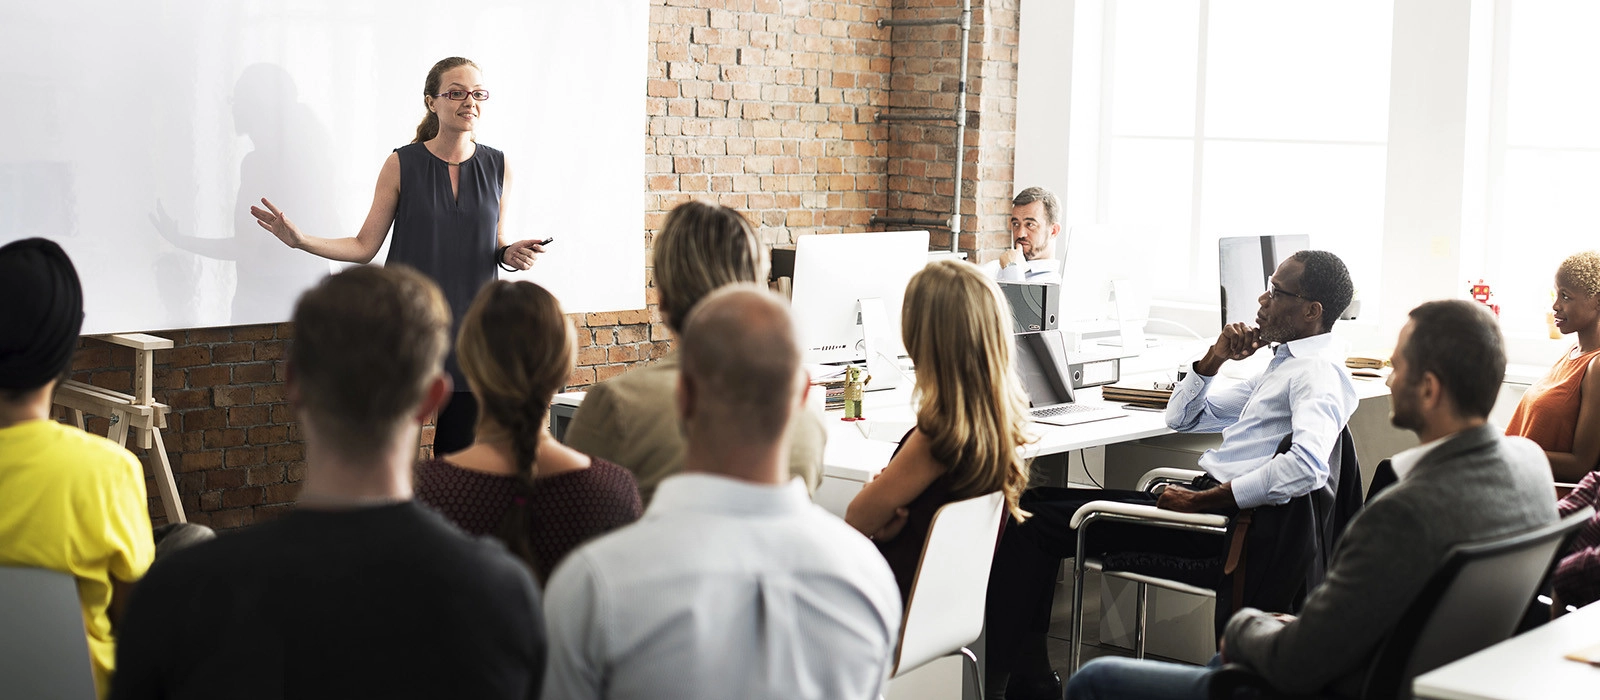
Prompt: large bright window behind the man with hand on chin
<box><xmin>1067</xmin><ymin>0</ymin><xmax>1392</xmax><ymax>304</ymax></box>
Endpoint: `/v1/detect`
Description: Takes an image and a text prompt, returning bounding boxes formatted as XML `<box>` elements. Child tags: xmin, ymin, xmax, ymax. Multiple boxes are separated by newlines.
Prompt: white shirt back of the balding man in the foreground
<box><xmin>544</xmin><ymin>473</ymin><xmax>901</xmax><ymax>700</ymax></box>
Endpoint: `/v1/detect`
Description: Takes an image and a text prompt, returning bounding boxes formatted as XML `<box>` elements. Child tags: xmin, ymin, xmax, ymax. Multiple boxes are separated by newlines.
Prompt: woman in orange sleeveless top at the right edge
<box><xmin>1506</xmin><ymin>251</ymin><xmax>1600</xmax><ymax>483</ymax></box>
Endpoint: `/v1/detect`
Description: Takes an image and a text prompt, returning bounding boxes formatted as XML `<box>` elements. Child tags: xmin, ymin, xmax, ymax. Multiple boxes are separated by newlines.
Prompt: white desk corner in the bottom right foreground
<box><xmin>1411</xmin><ymin>604</ymin><xmax>1600</xmax><ymax>700</ymax></box>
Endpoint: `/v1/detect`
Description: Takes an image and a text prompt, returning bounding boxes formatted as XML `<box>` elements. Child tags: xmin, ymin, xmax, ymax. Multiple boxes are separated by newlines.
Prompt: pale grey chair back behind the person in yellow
<box><xmin>0</xmin><ymin>566</ymin><xmax>94</xmax><ymax>700</ymax></box>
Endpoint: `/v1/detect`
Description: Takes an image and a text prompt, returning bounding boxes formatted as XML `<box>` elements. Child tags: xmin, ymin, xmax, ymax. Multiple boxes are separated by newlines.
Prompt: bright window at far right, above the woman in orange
<box><xmin>1462</xmin><ymin>0</ymin><xmax>1600</xmax><ymax>345</ymax></box>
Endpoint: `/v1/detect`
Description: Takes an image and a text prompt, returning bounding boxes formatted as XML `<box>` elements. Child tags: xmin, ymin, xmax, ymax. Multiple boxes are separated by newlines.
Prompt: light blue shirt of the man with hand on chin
<box><xmin>1166</xmin><ymin>332</ymin><xmax>1357</xmax><ymax>508</ymax></box>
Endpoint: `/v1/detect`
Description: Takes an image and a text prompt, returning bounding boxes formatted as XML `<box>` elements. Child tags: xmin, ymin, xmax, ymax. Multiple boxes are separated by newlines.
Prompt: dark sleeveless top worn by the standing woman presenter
<box><xmin>384</xmin><ymin>144</ymin><xmax>506</xmax><ymax>383</ymax></box>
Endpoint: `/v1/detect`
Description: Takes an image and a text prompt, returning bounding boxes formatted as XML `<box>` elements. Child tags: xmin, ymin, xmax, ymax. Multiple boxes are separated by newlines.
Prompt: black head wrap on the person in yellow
<box><xmin>0</xmin><ymin>238</ymin><xmax>83</xmax><ymax>390</ymax></box>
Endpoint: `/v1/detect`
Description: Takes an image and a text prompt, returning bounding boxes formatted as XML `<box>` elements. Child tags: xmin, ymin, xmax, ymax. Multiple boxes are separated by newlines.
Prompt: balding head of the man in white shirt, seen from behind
<box><xmin>678</xmin><ymin>284</ymin><xmax>805</xmax><ymax>443</ymax></box>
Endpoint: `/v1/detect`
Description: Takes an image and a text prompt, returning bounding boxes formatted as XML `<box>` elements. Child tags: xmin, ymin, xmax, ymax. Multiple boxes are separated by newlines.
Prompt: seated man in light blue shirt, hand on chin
<box><xmin>989</xmin><ymin>251</ymin><xmax>1357</xmax><ymax>700</ymax></box>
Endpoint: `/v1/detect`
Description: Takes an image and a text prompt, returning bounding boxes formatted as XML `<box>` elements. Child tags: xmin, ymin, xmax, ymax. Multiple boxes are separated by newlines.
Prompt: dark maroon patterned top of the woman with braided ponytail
<box><xmin>416</xmin><ymin>459</ymin><xmax>643</xmax><ymax>585</ymax></box>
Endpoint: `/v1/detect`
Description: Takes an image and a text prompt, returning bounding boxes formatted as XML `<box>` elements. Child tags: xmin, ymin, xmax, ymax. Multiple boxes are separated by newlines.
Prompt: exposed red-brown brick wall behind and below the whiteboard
<box><xmin>65</xmin><ymin>0</ymin><xmax>1018</xmax><ymax>529</ymax></box>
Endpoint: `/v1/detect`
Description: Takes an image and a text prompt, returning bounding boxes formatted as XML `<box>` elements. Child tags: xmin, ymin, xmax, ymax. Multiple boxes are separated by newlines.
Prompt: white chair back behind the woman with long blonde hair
<box><xmin>893</xmin><ymin>491</ymin><xmax>1005</xmax><ymax>676</ymax></box>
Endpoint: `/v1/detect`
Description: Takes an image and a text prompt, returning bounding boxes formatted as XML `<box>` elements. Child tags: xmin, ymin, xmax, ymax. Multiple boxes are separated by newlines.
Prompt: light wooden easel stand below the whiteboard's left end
<box><xmin>56</xmin><ymin>332</ymin><xmax>187</xmax><ymax>523</ymax></box>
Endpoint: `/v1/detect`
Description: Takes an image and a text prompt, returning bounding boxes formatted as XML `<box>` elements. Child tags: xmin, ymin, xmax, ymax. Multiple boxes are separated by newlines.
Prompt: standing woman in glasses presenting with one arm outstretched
<box><xmin>250</xmin><ymin>58</ymin><xmax>544</xmax><ymax>454</ymax></box>
